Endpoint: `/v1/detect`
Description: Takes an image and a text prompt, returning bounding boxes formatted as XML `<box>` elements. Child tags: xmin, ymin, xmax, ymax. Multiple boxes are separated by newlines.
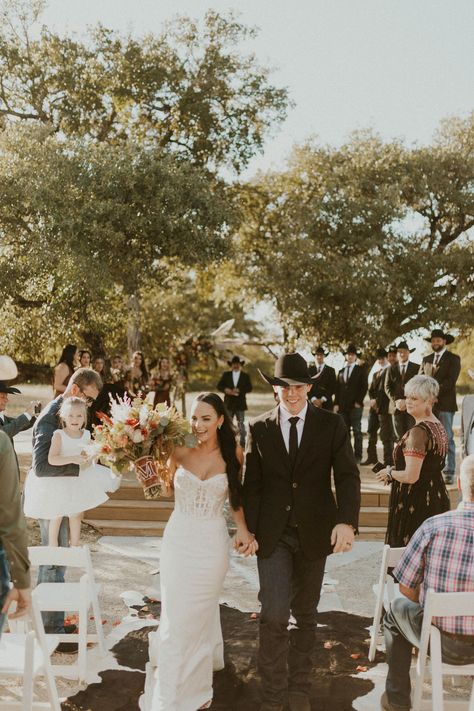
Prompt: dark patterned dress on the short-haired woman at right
<box><xmin>385</xmin><ymin>420</ymin><xmax>450</xmax><ymax>548</ymax></box>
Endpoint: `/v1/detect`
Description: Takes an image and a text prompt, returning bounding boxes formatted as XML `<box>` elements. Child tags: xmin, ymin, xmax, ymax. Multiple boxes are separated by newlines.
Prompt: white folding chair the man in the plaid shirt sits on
<box><xmin>413</xmin><ymin>590</ymin><xmax>474</xmax><ymax>711</ymax></box>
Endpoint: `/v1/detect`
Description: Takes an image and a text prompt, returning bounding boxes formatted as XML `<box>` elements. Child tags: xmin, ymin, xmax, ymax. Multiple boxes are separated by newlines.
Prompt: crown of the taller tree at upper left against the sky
<box><xmin>0</xmin><ymin>4</ymin><xmax>288</xmax><ymax>170</ymax></box>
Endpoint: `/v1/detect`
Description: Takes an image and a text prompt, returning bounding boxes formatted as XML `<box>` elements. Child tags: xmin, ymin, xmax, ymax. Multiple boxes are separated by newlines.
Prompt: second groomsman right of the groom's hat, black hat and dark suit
<box><xmin>334</xmin><ymin>343</ymin><xmax>368</xmax><ymax>462</ymax></box>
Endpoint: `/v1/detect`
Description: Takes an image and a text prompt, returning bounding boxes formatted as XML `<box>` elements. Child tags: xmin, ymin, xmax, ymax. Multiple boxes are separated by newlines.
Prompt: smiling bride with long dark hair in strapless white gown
<box><xmin>147</xmin><ymin>393</ymin><xmax>258</xmax><ymax>711</ymax></box>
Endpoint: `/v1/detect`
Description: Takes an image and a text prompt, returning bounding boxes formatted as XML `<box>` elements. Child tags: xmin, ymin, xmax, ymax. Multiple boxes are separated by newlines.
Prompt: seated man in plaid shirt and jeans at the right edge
<box><xmin>381</xmin><ymin>456</ymin><xmax>474</xmax><ymax>711</ymax></box>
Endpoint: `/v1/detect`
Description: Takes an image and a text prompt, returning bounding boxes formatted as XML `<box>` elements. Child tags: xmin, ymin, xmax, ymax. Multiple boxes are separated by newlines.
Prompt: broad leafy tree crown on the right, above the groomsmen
<box><xmin>236</xmin><ymin>115</ymin><xmax>474</xmax><ymax>356</ymax></box>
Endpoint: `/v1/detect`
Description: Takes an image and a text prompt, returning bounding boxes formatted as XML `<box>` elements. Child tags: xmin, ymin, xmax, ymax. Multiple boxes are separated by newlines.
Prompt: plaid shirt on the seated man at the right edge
<box><xmin>393</xmin><ymin>501</ymin><xmax>474</xmax><ymax>635</ymax></box>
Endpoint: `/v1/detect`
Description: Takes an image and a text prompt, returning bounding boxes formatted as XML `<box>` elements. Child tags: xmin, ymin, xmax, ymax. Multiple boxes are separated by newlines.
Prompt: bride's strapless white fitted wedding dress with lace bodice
<box><xmin>150</xmin><ymin>467</ymin><xmax>229</xmax><ymax>711</ymax></box>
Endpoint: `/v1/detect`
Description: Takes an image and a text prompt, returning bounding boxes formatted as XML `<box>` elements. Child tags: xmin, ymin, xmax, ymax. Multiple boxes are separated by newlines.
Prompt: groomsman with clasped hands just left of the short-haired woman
<box><xmin>385</xmin><ymin>341</ymin><xmax>420</xmax><ymax>439</ymax></box>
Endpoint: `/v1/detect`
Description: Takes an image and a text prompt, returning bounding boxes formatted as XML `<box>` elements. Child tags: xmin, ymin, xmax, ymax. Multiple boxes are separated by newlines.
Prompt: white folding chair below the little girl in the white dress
<box><xmin>28</xmin><ymin>546</ymin><xmax>106</xmax><ymax>681</ymax></box>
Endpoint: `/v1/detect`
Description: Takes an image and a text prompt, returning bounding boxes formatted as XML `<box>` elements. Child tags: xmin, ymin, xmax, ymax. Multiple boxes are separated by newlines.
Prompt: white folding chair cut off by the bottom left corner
<box><xmin>0</xmin><ymin>599</ymin><xmax>61</xmax><ymax>711</ymax></box>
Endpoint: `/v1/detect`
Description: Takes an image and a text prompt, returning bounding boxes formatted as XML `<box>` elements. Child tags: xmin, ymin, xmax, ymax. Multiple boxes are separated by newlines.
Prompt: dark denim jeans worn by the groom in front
<box><xmin>258</xmin><ymin>527</ymin><xmax>326</xmax><ymax>706</ymax></box>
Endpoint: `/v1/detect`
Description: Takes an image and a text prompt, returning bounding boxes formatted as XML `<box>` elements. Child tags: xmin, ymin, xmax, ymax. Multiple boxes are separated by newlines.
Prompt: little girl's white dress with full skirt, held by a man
<box><xmin>24</xmin><ymin>430</ymin><xmax>120</xmax><ymax>519</ymax></box>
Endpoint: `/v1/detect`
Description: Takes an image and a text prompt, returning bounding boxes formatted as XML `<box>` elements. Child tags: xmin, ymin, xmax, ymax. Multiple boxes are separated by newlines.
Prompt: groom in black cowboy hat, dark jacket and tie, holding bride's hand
<box><xmin>243</xmin><ymin>353</ymin><xmax>360</xmax><ymax>711</ymax></box>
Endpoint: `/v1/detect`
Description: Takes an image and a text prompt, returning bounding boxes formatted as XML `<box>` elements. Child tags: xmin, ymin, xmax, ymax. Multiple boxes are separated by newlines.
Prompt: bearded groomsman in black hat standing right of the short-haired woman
<box><xmin>420</xmin><ymin>328</ymin><xmax>461</xmax><ymax>484</ymax></box>
